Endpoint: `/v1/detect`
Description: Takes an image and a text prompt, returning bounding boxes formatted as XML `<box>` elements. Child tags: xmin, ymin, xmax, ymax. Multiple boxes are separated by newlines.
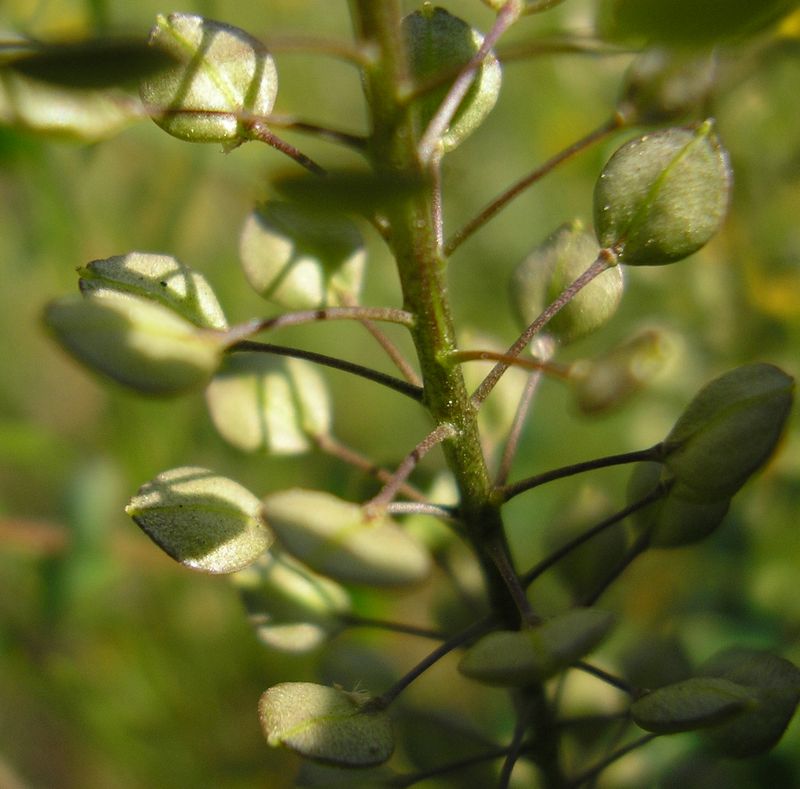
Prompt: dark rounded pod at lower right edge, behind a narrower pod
<box><xmin>700</xmin><ymin>649</ymin><xmax>800</xmax><ymax>759</ymax></box>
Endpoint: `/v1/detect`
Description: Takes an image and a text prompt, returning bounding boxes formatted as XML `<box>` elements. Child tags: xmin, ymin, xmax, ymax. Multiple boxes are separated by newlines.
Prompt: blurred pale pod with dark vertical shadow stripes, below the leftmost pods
<box><xmin>206</xmin><ymin>353</ymin><xmax>331</xmax><ymax>455</ymax></box>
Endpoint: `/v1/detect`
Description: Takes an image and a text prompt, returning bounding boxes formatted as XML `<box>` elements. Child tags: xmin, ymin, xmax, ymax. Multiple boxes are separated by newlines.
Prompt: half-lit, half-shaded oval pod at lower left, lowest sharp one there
<box><xmin>258</xmin><ymin>682</ymin><xmax>394</xmax><ymax>767</ymax></box>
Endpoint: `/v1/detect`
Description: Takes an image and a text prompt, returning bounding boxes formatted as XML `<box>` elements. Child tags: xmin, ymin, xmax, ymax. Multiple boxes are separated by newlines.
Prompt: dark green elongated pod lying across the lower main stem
<box><xmin>458</xmin><ymin>608</ymin><xmax>614</xmax><ymax>687</ymax></box>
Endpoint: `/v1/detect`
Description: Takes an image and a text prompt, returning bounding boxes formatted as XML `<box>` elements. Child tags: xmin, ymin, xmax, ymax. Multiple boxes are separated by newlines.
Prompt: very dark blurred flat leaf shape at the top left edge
<box><xmin>7</xmin><ymin>38</ymin><xmax>175</xmax><ymax>90</ymax></box>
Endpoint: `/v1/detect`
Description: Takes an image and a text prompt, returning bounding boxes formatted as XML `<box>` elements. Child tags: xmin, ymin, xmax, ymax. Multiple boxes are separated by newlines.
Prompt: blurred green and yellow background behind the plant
<box><xmin>0</xmin><ymin>0</ymin><xmax>800</xmax><ymax>789</ymax></box>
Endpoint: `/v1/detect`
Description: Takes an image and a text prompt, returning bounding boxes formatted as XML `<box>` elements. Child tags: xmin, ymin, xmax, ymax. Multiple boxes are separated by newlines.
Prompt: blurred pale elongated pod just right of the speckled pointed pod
<box><xmin>263</xmin><ymin>488</ymin><xmax>431</xmax><ymax>586</ymax></box>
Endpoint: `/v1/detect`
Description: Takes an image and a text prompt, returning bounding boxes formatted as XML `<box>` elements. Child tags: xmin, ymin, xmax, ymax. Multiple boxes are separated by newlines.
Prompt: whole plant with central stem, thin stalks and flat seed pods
<box><xmin>0</xmin><ymin>0</ymin><xmax>800</xmax><ymax>789</ymax></box>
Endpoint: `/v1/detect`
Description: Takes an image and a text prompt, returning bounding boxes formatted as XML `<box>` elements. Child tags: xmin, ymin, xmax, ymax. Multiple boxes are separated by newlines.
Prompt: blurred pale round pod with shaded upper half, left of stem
<box><xmin>239</xmin><ymin>201</ymin><xmax>366</xmax><ymax>310</ymax></box>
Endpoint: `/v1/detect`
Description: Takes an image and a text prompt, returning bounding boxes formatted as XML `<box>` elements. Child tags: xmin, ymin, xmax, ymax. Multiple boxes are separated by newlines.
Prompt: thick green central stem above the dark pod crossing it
<box><xmin>351</xmin><ymin>0</ymin><xmax>519</xmax><ymax>624</ymax></box>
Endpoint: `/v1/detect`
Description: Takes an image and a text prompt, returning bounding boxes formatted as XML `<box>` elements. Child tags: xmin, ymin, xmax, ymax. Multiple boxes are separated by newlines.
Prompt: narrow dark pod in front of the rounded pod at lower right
<box><xmin>631</xmin><ymin>677</ymin><xmax>755</xmax><ymax>734</ymax></box>
